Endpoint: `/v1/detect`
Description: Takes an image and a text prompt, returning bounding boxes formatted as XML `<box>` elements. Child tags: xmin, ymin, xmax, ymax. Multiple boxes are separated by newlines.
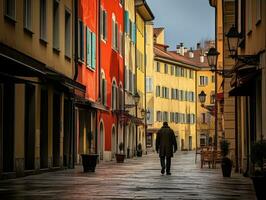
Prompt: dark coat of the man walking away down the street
<box><xmin>156</xmin><ymin>125</ymin><xmax>177</xmax><ymax>157</ymax></box>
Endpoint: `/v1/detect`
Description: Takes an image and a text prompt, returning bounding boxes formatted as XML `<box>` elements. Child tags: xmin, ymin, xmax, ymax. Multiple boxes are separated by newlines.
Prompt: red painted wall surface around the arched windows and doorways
<box><xmin>98</xmin><ymin>0</ymin><xmax>124</xmax><ymax>151</ymax></box>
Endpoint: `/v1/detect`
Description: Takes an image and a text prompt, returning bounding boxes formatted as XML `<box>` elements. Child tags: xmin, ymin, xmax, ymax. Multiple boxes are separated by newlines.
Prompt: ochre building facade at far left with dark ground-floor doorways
<box><xmin>0</xmin><ymin>0</ymin><xmax>85</xmax><ymax>177</ymax></box>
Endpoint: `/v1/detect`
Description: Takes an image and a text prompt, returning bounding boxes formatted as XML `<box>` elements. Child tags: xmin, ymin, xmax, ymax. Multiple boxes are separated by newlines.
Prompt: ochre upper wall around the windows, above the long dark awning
<box><xmin>0</xmin><ymin>0</ymin><xmax>74</xmax><ymax>78</ymax></box>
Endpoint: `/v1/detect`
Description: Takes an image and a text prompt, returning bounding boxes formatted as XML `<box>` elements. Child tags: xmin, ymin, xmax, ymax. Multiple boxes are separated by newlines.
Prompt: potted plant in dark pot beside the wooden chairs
<box><xmin>220</xmin><ymin>139</ymin><xmax>233</xmax><ymax>177</ymax></box>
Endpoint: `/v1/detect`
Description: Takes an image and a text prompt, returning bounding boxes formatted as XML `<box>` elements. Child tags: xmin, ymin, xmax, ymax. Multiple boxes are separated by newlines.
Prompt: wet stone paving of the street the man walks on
<box><xmin>0</xmin><ymin>152</ymin><xmax>256</xmax><ymax>200</ymax></box>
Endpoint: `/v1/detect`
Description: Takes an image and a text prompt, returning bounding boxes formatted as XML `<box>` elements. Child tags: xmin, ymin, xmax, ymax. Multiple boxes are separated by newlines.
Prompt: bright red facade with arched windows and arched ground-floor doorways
<box><xmin>98</xmin><ymin>0</ymin><xmax>124</xmax><ymax>160</ymax></box>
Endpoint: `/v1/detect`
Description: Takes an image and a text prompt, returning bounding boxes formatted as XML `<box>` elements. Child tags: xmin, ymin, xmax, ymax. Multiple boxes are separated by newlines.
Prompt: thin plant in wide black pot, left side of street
<box><xmin>81</xmin><ymin>131</ymin><xmax>99</xmax><ymax>172</ymax></box>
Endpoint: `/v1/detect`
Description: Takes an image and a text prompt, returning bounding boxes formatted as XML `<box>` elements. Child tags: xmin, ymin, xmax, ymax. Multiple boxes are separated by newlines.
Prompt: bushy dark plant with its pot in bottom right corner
<box><xmin>250</xmin><ymin>140</ymin><xmax>266</xmax><ymax>199</ymax></box>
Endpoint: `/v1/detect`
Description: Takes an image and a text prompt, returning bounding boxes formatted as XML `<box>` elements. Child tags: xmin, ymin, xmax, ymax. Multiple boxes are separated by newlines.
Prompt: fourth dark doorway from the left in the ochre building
<box><xmin>53</xmin><ymin>92</ymin><xmax>61</xmax><ymax>167</ymax></box>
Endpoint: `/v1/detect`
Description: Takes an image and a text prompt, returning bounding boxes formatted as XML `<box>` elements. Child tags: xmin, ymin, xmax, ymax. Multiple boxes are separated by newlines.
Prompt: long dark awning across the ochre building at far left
<box><xmin>0</xmin><ymin>44</ymin><xmax>86</xmax><ymax>93</ymax></box>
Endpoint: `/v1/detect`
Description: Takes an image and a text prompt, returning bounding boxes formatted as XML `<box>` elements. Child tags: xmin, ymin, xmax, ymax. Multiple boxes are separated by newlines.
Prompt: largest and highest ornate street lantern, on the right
<box><xmin>225</xmin><ymin>25</ymin><xmax>241</xmax><ymax>58</ymax></box>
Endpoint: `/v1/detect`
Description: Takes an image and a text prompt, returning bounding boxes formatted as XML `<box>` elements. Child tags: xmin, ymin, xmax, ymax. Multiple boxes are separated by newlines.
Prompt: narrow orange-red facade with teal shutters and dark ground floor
<box><xmin>75</xmin><ymin>0</ymin><xmax>101</xmax><ymax>163</ymax></box>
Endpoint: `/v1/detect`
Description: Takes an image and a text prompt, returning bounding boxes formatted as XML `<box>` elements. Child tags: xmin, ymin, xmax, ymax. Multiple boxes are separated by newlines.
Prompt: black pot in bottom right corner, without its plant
<box><xmin>251</xmin><ymin>176</ymin><xmax>266</xmax><ymax>200</ymax></box>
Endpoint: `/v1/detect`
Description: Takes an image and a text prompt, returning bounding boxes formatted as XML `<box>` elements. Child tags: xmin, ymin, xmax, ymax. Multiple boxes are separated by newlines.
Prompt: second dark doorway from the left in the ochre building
<box><xmin>24</xmin><ymin>84</ymin><xmax>35</xmax><ymax>170</ymax></box>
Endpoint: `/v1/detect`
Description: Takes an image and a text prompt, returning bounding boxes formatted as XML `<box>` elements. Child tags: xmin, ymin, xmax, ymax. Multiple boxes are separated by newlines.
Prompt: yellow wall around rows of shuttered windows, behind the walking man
<box><xmin>152</xmin><ymin>58</ymin><xmax>196</xmax><ymax>149</ymax></box>
